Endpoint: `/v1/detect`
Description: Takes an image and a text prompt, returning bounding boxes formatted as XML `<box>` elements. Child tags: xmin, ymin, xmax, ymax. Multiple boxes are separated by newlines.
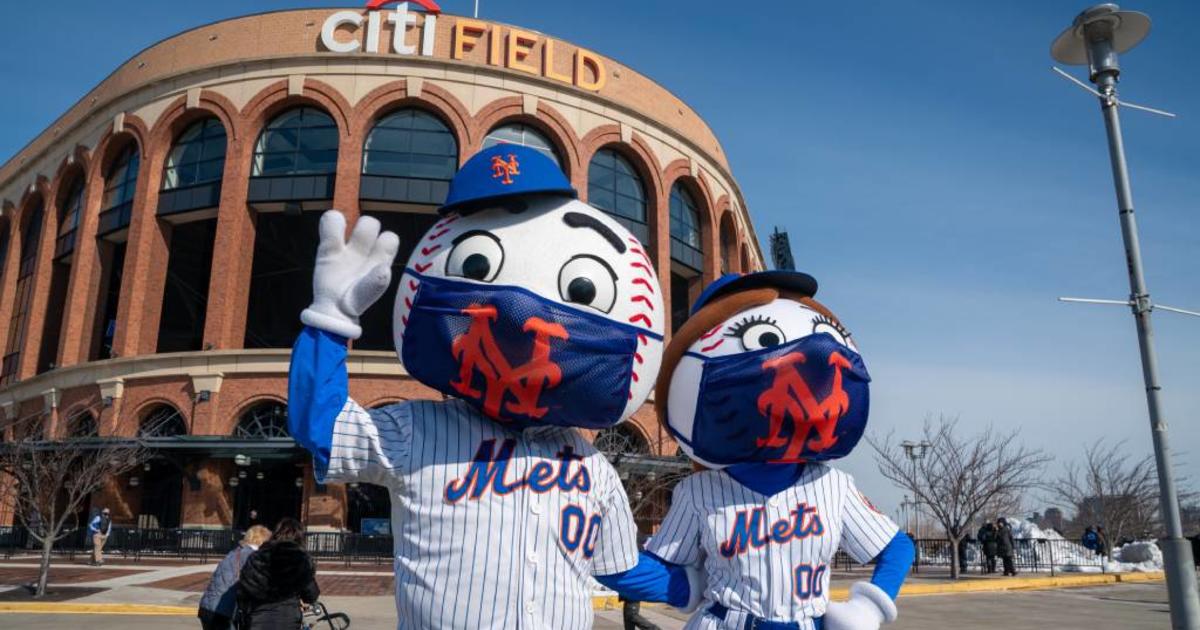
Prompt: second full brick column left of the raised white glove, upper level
<box><xmin>113</xmin><ymin>146</ymin><xmax>170</xmax><ymax>356</ymax></box>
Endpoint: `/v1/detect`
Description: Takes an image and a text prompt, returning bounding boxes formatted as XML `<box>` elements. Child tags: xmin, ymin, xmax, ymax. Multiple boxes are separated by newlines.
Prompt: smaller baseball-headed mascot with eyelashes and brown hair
<box><xmin>648</xmin><ymin>271</ymin><xmax>913</xmax><ymax>630</ymax></box>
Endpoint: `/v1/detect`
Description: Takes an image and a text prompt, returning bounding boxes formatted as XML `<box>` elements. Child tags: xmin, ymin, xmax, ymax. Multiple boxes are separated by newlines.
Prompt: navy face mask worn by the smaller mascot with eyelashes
<box><xmin>672</xmin><ymin>334</ymin><xmax>871</xmax><ymax>466</ymax></box>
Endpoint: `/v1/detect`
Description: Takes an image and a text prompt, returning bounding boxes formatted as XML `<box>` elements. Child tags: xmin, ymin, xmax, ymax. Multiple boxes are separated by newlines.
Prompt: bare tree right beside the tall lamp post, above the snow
<box><xmin>1048</xmin><ymin>439</ymin><xmax>1176</xmax><ymax>542</ymax></box>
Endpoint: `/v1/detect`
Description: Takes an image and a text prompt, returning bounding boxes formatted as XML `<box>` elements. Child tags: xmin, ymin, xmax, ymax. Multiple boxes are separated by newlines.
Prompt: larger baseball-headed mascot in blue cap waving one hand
<box><xmin>288</xmin><ymin>145</ymin><xmax>702</xmax><ymax>629</ymax></box>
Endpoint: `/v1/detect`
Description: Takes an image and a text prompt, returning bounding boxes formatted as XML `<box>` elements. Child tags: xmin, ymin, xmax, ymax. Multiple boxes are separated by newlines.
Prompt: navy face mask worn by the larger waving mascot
<box><xmin>401</xmin><ymin>269</ymin><xmax>660</xmax><ymax>430</ymax></box>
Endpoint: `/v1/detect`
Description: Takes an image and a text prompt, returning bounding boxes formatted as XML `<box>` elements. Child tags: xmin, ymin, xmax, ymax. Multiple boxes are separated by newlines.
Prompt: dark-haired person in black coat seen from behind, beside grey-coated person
<box><xmin>238</xmin><ymin>518</ymin><xmax>320</xmax><ymax>630</ymax></box>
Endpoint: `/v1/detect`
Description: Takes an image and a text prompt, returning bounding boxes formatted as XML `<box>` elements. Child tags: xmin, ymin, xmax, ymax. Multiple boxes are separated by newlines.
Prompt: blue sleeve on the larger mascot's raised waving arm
<box><xmin>288</xmin><ymin>326</ymin><xmax>349</xmax><ymax>479</ymax></box>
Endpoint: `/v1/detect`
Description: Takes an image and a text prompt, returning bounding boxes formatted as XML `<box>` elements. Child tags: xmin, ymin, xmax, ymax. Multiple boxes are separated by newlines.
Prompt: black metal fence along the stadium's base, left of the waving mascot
<box><xmin>0</xmin><ymin>526</ymin><xmax>394</xmax><ymax>564</ymax></box>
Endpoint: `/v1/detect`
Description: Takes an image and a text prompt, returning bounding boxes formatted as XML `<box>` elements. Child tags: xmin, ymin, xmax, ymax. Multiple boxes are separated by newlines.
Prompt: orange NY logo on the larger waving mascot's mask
<box><xmin>450</xmin><ymin>305</ymin><xmax>568</xmax><ymax>420</ymax></box>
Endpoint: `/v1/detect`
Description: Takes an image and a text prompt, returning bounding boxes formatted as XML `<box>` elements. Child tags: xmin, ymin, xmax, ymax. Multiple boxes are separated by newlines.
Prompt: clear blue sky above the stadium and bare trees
<box><xmin>0</xmin><ymin>0</ymin><xmax>1200</xmax><ymax>514</ymax></box>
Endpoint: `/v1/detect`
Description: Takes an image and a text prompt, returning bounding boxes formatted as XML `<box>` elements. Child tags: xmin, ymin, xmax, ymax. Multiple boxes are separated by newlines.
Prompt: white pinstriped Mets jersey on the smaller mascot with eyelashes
<box><xmin>647</xmin><ymin>463</ymin><xmax>898</xmax><ymax>630</ymax></box>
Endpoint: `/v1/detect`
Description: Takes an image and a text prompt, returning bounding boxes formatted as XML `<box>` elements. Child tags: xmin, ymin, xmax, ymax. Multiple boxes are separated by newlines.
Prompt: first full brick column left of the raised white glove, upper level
<box><xmin>204</xmin><ymin>139</ymin><xmax>254</xmax><ymax>349</ymax></box>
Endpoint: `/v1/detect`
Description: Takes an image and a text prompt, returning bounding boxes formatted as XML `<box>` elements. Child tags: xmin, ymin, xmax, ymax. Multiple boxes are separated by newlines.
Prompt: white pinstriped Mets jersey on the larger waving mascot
<box><xmin>326</xmin><ymin>400</ymin><xmax>638</xmax><ymax>630</ymax></box>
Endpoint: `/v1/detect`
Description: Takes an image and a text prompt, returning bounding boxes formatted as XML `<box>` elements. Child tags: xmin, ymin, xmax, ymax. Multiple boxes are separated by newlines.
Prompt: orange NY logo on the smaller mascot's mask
<box><xmin>757</xmin><ymin>352</ymin><xmax>851</xmax><ymax>462</ymax></box>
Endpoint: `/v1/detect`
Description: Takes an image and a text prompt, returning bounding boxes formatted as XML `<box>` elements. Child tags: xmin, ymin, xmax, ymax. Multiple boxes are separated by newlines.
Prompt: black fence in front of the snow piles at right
<box><xmin>913</xmin><ymin>538</ymin><xmax>1106</xmax><ymax>575</ymax></box>
